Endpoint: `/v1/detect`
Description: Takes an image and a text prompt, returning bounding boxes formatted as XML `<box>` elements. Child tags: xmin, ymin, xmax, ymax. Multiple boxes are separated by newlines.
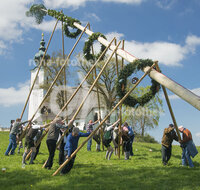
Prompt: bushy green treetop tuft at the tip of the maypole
<box><xmin>26</xmin><ymin>4</ymin><xmax>47</xmax><ymax>24</ymax></box>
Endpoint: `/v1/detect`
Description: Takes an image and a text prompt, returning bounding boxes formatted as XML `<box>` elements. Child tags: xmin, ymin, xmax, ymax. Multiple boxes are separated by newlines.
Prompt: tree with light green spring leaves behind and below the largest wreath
<box><xmin>123</xmin><ymin>86</ymin><xmax>164</xmax><ymax>137</ymax></box>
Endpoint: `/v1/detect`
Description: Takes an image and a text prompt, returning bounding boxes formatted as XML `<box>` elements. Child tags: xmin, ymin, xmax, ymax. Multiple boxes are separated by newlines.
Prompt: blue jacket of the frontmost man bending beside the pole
<box><xmin>64</xmin><ymin>132</ymin><xmax>90</xmax><ymax>157</ymax></box>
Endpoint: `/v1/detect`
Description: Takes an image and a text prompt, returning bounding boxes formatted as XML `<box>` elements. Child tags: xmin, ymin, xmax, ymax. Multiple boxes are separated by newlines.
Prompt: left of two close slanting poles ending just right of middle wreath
<box><xmin>26</xmin><ymin>38</ymin><xmax>115</xmax><ymax>159</ymax></box>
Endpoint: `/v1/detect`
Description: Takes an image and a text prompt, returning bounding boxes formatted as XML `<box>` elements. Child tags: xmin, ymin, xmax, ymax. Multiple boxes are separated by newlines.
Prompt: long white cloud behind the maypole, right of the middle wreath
<box><xmin>101</xmin><ymin>32</ymin><xmax>200</xmax><ymax>66</ymax></box>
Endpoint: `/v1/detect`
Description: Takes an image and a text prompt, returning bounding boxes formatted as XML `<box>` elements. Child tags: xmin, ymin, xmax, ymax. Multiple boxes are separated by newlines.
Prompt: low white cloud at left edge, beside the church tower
<box><xmin>0</xmin><ymin>81</ymin><xmax>30</xmax><ymax>107</ymax></box>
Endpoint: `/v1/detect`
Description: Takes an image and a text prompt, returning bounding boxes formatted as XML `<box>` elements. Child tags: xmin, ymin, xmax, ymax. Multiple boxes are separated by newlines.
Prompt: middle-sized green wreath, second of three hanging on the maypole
<box><xmin>83</xmin><ymin>32</ymin><xmax>106</xmax><ymax>61</ymax></box>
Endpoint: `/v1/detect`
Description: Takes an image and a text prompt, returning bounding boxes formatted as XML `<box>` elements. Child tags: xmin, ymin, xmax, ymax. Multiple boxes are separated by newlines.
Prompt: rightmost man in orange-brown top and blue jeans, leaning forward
<box><xmin>178</xmin><ymin>126</ymin><xmax>198</xmax><ymax>168</ymax></box>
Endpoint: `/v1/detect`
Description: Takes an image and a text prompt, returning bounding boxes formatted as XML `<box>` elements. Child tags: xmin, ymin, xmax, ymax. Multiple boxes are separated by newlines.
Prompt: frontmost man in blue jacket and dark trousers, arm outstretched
<box><xmin>61</xmin><ymin>127</ymin><xmax>90</xmax><ymax>174</ymax></box>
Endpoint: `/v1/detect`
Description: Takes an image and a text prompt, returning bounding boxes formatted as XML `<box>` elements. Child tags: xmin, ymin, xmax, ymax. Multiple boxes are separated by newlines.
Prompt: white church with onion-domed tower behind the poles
<box><xmin>28</xmin><ymin>34</ymin><xmax>115</xmax><ymax>130</ymax></box>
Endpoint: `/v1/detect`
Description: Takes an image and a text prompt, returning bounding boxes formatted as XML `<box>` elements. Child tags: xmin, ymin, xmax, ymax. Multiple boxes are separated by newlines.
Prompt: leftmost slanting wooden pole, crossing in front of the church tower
<box><xmin>20</xmin><ymin>20</ymin><xmax>58</xmax><ymax>119</ymax></box>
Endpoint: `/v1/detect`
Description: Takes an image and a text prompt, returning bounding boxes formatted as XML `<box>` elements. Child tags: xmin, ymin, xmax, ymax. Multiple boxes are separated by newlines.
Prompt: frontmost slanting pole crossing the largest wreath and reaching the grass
<box><xmin>52</xmin><ymin>61</ymin><xmax>155</xmax><ymax>176</ymax></box>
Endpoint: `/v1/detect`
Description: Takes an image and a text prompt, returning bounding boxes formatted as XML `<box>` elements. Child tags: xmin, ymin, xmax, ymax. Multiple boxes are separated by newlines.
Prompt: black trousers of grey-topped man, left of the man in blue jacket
<box><xmin>45</xmin><ymin>139</ymin><xmax>57</xmax><ymax>168</ymax></box>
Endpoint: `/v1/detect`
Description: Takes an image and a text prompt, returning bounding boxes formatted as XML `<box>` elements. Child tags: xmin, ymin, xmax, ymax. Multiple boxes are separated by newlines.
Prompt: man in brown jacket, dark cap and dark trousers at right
<box><xmin>161</xmin><ymin>124</ymin><xmax>178</xmax><ymax>165</ymax></box>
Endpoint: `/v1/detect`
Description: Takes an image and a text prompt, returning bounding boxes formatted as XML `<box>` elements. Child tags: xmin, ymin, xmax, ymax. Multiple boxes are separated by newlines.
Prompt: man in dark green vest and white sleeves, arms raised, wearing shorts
<box><xmin>103</xmin><ymin>120</ymin><xmax>119</xmax><ymax>160</ymax></box>
